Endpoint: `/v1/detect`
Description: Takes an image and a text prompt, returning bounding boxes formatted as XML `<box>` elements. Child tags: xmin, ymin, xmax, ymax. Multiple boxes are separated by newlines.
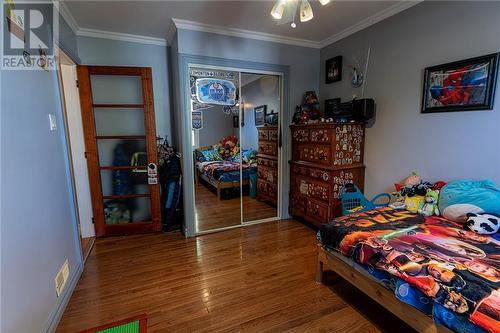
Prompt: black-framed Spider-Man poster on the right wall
<box><xmin>422</xmin><ymin>53</ymin><xmax>499</xmax><ymax>113</ymax></box>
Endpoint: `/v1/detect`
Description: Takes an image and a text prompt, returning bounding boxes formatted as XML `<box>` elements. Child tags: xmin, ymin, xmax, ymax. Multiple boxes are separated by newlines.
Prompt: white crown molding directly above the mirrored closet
<box><xmin>172</xmin><ymin>18</ymin><xmax>320</xmax><ymax>48</ymax></box>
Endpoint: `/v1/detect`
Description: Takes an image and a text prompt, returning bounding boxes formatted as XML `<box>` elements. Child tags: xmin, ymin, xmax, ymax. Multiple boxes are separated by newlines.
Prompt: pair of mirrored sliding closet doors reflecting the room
<box><xmin>188</xmin><ymin>65</ymin><xmax>283</xmax><ymax>234</ymax></box>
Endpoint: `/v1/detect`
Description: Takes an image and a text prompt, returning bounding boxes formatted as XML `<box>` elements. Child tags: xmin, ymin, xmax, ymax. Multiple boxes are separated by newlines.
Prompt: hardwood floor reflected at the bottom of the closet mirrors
<box><xmin>195</xmin><ymin>181</ymin><xmax>278</xmax><ymax>231</ymax></box>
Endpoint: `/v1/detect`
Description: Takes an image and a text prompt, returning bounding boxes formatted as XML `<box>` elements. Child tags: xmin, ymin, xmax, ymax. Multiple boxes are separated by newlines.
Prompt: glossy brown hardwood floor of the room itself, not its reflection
<box><xmin>57</xmin><ymin>220</ymin><xmax>412</xmax><ymax>333</ymax></box>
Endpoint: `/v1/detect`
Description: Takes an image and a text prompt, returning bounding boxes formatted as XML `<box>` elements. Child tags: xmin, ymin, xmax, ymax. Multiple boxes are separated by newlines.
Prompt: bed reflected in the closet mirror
<box><xmin>194</xmin><ymin>146</ymin><xmax>257</xmax><ymax>200</ymax></box>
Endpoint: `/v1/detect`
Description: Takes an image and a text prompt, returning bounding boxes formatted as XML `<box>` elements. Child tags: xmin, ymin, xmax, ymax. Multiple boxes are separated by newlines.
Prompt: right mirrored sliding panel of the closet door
<box><xmin>240</xmin><ymin>73</ymin><xmax>281</xmax><ymax>223</ymax></box>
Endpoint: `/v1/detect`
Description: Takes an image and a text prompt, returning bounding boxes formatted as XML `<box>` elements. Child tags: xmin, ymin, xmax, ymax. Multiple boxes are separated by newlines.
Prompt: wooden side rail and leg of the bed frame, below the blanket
<box><xmin>316</xmin><ymin>244</ymin><xmax>452</xmax><ymax>333</ymax></box>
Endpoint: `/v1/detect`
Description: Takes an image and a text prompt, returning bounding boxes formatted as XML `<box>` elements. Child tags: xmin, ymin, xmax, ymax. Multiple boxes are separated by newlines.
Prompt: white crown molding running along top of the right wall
<box><xmin>319</xmin><ymin>0</ymin><xmax>424</xmax><ymax>48</ymax></box>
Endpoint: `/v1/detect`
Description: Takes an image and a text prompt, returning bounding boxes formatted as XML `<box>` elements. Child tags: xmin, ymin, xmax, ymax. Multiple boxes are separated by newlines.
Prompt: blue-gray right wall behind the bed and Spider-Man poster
<box><xmin>320</xmin><ymin>1</ymin><xmax>500</xmax><ymax>195</ymax></box>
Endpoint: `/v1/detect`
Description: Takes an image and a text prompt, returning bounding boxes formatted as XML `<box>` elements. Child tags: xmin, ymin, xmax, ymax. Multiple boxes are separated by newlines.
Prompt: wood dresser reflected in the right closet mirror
<box><xmin>257</xmin><ymin>126</ymin><xmax>278</xmax><ymax>205</ymax></box>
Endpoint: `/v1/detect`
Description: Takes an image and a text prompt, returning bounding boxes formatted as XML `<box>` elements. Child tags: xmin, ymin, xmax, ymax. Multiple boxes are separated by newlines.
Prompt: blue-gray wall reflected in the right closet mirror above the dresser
<box><xmin>241</xmin><ymin>75</ymin><xmax>281</xmax><ymax>150</ymax></box>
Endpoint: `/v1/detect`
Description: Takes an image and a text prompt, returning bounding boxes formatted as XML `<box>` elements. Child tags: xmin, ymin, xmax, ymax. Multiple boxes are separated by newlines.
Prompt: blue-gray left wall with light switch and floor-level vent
<box><xmin>0</xmin><ymin>15</ymin><xmax>82</xmax><ymax>333</ymax></box>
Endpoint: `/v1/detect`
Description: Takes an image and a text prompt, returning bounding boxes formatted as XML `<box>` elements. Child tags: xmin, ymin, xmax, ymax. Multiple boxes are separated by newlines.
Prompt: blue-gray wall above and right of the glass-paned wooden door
<box><xmin>78</xmin><ymin>37</ymin><xmax>172</xmax><ymax>142</ymax></box>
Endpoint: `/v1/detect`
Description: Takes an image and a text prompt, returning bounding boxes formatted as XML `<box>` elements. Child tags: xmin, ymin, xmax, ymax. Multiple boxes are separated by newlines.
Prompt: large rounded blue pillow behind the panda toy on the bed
<box><xmin>439</xmin><ymin>179</ymin><xmax>500</xmax><ymax>223</ymax></box>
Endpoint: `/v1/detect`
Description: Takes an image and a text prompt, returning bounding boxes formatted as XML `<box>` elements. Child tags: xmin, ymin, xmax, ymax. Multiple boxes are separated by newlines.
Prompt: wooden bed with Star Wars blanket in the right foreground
<box><xmin>317</xmin><ymin>207</ymin><xmax>500</xmax><ymax>332</ymax></box>
